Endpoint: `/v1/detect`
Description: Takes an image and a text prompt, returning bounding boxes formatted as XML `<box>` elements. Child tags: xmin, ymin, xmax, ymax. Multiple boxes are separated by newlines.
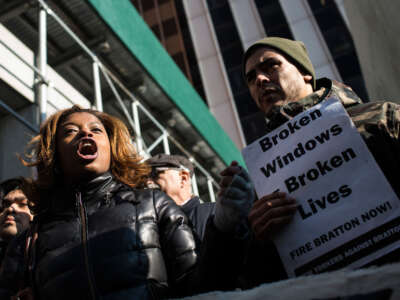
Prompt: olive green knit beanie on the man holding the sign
<box><xmin>242</xmin><ymin>37</ymin><xmax>316</xmax><ymax>90</ymax></box>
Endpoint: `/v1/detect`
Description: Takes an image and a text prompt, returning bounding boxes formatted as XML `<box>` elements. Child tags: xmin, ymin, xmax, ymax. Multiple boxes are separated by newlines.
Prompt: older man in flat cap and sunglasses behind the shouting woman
<box><xmin>146</xmin><ymin>154</ymin><xmax>215</xmax><ymax>240</ymax></box>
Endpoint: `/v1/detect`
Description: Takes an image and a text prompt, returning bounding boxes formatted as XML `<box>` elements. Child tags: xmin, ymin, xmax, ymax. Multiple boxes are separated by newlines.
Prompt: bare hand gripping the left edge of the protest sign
<box><xmin>249</xmin><ymin>192</ymin><xmax>297</xmax><ymax>241</ymax></box>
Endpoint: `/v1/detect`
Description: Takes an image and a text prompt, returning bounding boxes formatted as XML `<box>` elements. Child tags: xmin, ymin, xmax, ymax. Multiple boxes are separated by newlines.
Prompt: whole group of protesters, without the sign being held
<box><xmin>0</xmin><ymin>38</ymin><xmax>400</xmax><ymax>300</ymax></box>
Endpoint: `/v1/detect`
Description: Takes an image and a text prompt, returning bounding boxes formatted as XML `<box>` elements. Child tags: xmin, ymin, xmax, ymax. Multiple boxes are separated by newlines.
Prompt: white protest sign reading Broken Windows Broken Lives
<box><xmin>243</xmin><ymin>98</ymin><xmax>400</xmax><ymax>277</ymax></box>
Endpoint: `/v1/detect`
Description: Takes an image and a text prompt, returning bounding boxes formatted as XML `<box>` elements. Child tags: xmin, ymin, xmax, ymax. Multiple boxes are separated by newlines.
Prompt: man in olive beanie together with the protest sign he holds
<box><xmin>243</xmin><ymin>37</ymin><xmax>400</xmax><ymax>276</ymax></box>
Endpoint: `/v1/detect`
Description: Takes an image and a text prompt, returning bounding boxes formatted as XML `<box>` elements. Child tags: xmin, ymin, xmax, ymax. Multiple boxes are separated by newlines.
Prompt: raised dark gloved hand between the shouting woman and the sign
<box><xmin>214</xmin><ymin>161</ymin><xmax>254</xmax><ymax>232</ymax></box>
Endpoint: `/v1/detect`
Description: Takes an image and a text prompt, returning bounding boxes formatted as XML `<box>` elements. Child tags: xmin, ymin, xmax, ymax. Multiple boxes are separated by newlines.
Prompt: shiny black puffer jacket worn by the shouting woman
<box><xmin>0</xmin><ymin>174</ymin><xmax>197</xmax><ymax>300</ymax></box>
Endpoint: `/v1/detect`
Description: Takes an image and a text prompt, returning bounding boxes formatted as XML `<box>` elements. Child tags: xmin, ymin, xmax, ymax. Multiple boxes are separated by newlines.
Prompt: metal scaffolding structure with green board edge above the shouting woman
<box><xmin>0</xmin><ymin>0</ymin><xmax>247</xmax><ymax>201</ymax></box>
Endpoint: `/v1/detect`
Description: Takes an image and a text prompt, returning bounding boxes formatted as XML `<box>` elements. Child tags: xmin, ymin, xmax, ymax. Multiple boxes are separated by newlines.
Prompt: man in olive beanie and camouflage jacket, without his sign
<box><xmin>242</xmin><ymin>37</ymin><xmax>400</xmax><ymax>284</ymax></box>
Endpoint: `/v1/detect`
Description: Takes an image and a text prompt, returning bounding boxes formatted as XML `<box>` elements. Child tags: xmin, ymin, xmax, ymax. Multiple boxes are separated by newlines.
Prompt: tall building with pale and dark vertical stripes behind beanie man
<box><xmin>132</xmin><ymin>0</ymin><xmax>368</xmax><ymax>145</ymax></box>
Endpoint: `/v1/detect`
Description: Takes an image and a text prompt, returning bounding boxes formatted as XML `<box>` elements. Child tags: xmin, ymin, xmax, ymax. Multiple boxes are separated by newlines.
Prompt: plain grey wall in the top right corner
<box><xmin>343</xmin><ymin>0</ymin><xmax>400</xmax><ymax>103</ymax></box>
